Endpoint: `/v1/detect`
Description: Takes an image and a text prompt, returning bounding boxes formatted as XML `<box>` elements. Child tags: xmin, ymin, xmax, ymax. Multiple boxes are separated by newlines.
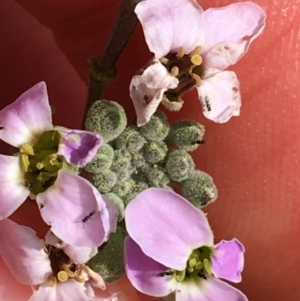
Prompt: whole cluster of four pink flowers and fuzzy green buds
<box><xmin>0</xmin><ymin>0</ymin><xmax>265</xmax><ymax>301</ymax></box>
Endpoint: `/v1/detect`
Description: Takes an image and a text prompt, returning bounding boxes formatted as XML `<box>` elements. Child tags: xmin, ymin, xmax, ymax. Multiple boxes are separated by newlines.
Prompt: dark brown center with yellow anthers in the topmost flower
<box><xmin>160</xmin><ymin>46</ymin><xmax>203</xmax><ymax>102</ymax></box>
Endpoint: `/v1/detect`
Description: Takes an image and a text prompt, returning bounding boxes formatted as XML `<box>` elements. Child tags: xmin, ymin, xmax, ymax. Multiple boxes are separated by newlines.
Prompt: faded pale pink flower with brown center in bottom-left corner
<box><xmin>0</xmin><ymin>219</ymin><xmax>105</xmax><ymax>301</ymax></box>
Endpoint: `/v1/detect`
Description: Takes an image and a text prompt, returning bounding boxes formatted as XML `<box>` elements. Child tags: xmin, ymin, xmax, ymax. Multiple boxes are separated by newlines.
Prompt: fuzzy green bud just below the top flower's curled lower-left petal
<box><xmin>139</xmin><ymin>111</ymin><xmax>170</xmax><ymax>141</ymax></box>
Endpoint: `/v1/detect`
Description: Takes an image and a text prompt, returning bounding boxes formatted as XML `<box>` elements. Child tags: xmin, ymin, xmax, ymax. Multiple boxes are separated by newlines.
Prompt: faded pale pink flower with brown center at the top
<box><xmin>130</xmin><ymin>0</ymin><xmax>266</xmax><ymax>125</ymax></box>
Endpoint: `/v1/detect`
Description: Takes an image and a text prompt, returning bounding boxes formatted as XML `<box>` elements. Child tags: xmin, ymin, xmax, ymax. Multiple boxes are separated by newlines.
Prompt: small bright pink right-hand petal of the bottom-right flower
<box><xmin>211</xmin><ymin>238</ymin><xmax>245</xmax><ymax>282</ymax></box>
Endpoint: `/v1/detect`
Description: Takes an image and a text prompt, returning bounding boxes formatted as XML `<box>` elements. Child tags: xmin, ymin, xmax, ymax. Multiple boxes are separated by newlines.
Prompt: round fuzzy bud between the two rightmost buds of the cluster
<box><xmin>166</xmin><ymin>149</ymin><xmax>195</xmax><ymax>182</ymax></box>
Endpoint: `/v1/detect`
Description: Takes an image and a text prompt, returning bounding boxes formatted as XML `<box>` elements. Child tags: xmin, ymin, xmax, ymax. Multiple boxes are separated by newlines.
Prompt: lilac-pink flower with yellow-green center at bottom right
<box><xmin>124</xmin><ymin>188</ymin><xmax>247</xmax><ymax>301</ymax></box>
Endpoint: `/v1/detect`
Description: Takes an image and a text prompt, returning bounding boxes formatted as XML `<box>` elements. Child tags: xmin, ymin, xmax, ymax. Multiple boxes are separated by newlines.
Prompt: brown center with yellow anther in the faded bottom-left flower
<box><xmin>46</xmin><ymin>245</ymin><xmax>85</xmax><ymax>286</ymax></box>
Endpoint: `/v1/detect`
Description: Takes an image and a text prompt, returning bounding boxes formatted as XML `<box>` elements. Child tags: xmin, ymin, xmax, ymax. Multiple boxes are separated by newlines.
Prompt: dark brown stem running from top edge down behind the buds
<box><xmin>84</xmin><ymin>0</ymin><xmax>142</xmax><ymax>125</ymax></box>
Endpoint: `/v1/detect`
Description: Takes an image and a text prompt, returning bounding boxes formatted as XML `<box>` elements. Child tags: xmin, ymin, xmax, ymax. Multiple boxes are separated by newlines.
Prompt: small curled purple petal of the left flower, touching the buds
<box><xmin>58</xmin><ymin>129</ymin><xmax>103</xmax><ymax>167</ymax></box>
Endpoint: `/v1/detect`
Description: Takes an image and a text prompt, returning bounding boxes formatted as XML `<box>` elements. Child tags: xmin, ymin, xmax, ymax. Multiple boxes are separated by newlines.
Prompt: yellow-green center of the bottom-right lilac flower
<box><xmin>160</xmin><ymin>247</ymin><xmax>213</xmax><ymax>282</ymax></box>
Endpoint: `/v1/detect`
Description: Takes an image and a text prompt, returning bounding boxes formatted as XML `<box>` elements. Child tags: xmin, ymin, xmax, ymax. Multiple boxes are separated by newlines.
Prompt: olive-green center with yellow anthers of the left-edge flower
<box><xmin>19</xmin><ymin>130</ymin><xmax>66</xmax><ymax>195</ymax></box>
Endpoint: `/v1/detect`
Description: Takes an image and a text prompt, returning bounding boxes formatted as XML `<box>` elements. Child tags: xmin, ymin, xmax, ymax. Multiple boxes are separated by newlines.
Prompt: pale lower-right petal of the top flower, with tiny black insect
<box><xmin>197</xmin><ymin>71</ymin><xmax>241</xmax><ymax>123</ymax></box>
